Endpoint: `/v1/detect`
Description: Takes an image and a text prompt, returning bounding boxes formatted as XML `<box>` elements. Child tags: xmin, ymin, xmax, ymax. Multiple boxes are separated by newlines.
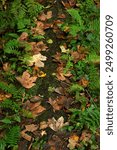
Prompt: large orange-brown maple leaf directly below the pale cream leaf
<box><xmin>16</xmin><ymin>71</ymin><xmax>37</xmax><ymax>89</ymax></box>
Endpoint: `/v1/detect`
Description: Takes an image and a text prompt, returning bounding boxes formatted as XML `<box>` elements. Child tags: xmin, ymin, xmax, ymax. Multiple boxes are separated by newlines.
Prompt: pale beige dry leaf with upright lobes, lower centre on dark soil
<box><xmin>48</xmin><ymin>116</ymin><xmax>69</xmax><ymax>131</ymax></box>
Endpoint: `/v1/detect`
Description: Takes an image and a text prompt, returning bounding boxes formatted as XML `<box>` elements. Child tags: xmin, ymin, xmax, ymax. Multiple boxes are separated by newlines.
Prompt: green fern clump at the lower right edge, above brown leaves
<box><xmin>70</xmin><ymin>104</ymin><xmax>99</xmax><ymax>133</ymax></box>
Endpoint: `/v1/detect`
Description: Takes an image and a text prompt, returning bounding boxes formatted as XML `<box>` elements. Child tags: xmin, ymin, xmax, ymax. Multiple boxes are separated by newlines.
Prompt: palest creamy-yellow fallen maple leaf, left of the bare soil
<box><xmin>28</xmin><ymin>53</ymin><xmax>47</xmax><ymax>67</ymax></box>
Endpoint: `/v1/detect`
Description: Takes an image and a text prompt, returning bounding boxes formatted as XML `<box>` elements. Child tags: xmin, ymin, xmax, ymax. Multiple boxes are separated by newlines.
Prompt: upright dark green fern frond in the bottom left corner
<box><xmin>5</xmin><ymin>126</ymin><xmax>20</xmax><ymax>147</ymax></box>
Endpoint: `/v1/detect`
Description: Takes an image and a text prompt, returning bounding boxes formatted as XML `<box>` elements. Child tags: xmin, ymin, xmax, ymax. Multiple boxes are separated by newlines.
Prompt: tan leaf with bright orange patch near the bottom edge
<box><xmin>67</xmin><ymin>134</ymin><xmax>79</xmax><ymax>150</ymax></box>
